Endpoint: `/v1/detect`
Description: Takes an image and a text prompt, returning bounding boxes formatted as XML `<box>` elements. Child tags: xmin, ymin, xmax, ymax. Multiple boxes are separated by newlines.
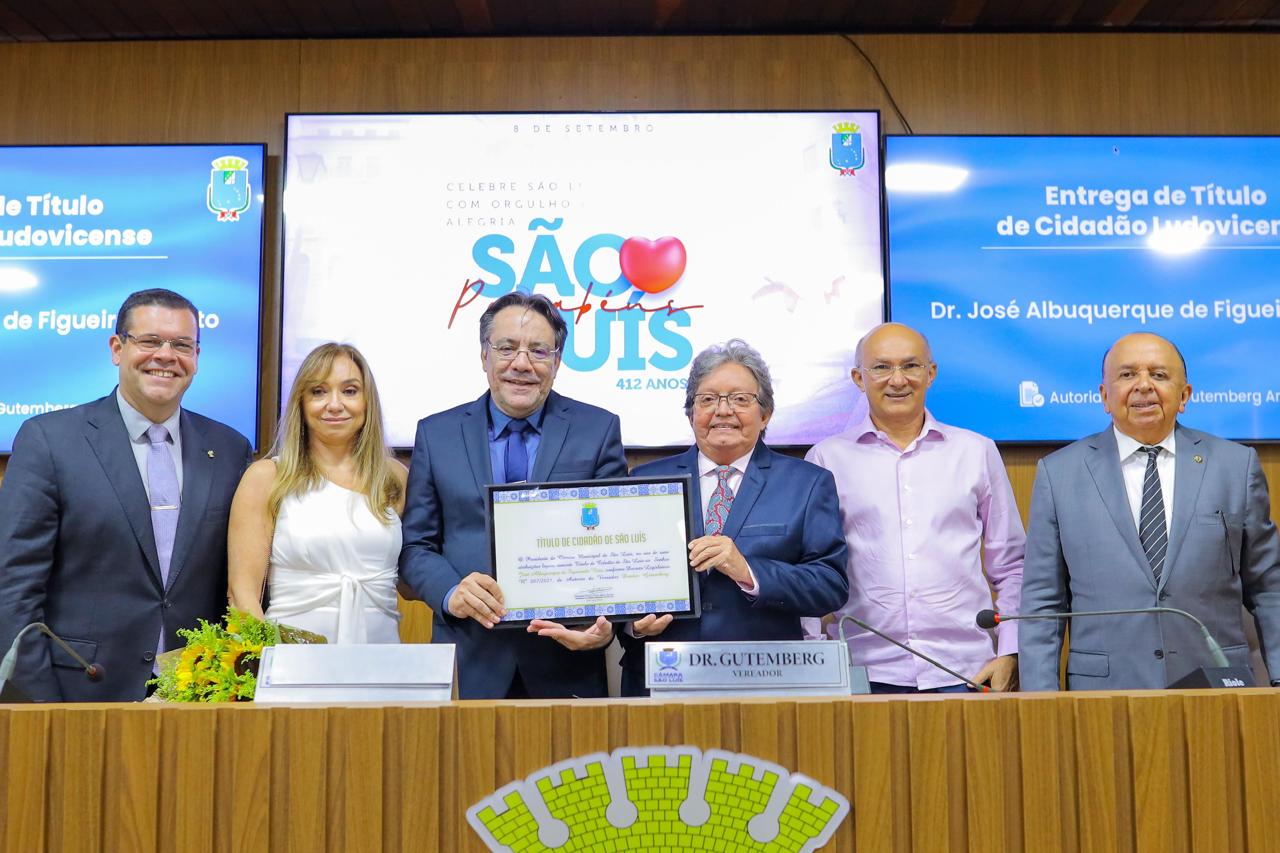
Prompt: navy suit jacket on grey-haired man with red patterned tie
<box><xmin>618</xmin><ymin>442</ymin><xmax>849</xmax><ymax>695</ymax></box>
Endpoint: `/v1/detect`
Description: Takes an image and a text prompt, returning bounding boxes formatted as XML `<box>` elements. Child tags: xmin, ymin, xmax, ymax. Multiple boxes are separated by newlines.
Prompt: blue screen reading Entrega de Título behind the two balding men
<box><xmin>884</xmin><ymin>136</ymin><xmax>1280</xmax><ymax>442</ymax></box>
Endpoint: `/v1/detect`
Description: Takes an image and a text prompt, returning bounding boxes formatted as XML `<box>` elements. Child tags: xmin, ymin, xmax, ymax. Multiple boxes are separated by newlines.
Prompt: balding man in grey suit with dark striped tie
<box><xmin>1019</xmin><ymin>333</ymin><xmax>1280</xmax><ymax>690</ymax></box>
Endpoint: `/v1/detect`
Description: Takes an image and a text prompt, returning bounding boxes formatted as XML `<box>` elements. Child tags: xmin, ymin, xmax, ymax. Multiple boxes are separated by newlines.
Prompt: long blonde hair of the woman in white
<box><xmin>266</xmin><ymin>343</ymin><xmax>401</xmax><ymax>524</ymax></box>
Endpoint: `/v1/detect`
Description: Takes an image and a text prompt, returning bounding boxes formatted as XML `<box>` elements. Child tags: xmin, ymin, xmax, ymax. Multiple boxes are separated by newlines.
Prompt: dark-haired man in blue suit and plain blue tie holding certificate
<box><xmin>399</xmin><ymin>291</ymin><xmax>627</xmax><ymax>699</ymax></box>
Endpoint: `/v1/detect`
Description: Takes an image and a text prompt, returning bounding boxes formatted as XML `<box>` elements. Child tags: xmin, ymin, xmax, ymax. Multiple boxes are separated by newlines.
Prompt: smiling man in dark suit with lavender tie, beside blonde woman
<box><xmin>0</xmin><ymin>289</ymin><xmax>251</xmax><ymax>702</ymax></box>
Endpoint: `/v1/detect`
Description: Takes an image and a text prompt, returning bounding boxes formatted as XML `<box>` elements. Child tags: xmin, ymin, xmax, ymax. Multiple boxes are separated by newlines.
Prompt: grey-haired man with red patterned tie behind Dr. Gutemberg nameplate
<box><xmin>621</xmin><ymin>339</ymin><xmax>849</xmax><ymax>695</ymax></box>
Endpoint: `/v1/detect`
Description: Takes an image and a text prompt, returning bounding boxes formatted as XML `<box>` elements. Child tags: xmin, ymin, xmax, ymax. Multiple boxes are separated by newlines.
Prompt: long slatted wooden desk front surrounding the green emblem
<box><xmin>0</xmin><ymin>689</ymin><xmax>1280</xmax><ymax>853</ymax></box>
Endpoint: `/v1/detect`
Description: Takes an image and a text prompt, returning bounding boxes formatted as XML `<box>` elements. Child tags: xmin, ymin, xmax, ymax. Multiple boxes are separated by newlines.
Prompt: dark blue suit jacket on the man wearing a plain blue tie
<box><xmin>399</xmin><ymin>391</ymin><xmax>627</xmax><ymax>699</ymax></box>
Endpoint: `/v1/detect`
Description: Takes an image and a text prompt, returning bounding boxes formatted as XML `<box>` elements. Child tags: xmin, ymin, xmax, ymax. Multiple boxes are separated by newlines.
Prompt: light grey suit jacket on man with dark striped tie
<box><xmin>1018</xmin><ymin>427</ymin><xmax>1280</xmax><ymax>690</ymax></box>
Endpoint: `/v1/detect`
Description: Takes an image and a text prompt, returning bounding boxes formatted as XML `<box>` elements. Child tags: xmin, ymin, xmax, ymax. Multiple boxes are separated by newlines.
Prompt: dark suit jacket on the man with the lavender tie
<box><xmin>0</xmin><ymin>393</ymin><xmax>251</xmax><ymax>702</ymax></box>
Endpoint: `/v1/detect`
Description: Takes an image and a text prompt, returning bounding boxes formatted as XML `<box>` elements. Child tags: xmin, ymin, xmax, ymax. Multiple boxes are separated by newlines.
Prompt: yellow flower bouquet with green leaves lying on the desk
<box><xmin>150</xmin><ymin>607</ymin><xmax>325</xmax><ymax>702</ymax></box>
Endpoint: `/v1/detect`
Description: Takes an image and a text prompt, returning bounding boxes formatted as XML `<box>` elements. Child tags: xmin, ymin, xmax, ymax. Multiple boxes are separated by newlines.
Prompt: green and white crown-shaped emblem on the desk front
<box><xmin>467</xmin><ymin>747</ymin><xmax>849</xmax><ymax>853</ymax></box>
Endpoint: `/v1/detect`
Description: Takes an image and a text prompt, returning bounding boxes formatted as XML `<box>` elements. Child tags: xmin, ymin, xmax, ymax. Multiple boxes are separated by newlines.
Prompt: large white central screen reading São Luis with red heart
<box><xmin>282</xmin><ymin>110</ymin><xmax>883</xmax><ymax>447</ymax></box>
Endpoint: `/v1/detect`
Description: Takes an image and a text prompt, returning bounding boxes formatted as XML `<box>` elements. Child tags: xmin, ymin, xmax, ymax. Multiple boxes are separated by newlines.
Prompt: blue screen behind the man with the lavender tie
<box><xmin>0</xmin><ymin>145</ymin><xmax>265</xmax><ymax>452</ymax></box>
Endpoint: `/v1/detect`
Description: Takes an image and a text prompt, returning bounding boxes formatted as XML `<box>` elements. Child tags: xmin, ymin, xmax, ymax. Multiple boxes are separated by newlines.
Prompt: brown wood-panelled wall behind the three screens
<box><xmin>0</xmin><ymin>33</ymin><xmax>1280</xmax><ymax>568</ymax></box>
